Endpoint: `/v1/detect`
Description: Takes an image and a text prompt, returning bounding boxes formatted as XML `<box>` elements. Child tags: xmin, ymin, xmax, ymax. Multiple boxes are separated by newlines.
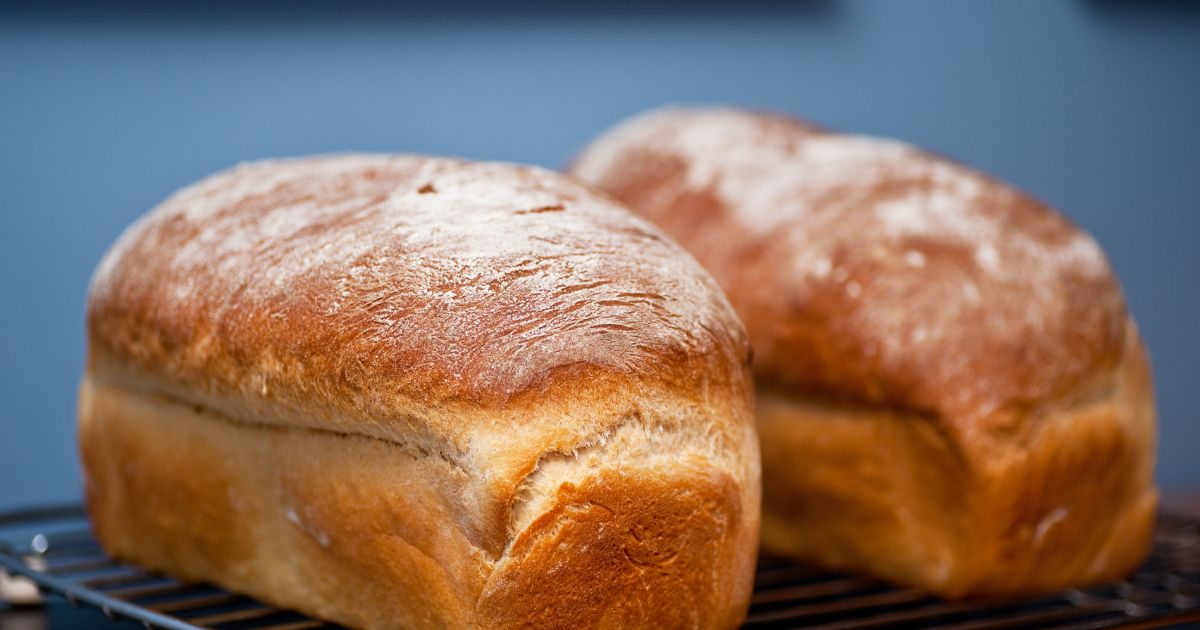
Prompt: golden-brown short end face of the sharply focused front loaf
<box><xmin>479</xmin><ymin>469</ymin><xmax>756</xmax><ymax>628</ymax></box>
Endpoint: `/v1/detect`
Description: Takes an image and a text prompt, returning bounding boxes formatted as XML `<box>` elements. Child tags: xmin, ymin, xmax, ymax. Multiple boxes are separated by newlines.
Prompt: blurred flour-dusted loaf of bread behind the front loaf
<box><xmin>571</xmin><ymin>108</ymin><xmax>1157</xmax><ymax>596</ymax></box>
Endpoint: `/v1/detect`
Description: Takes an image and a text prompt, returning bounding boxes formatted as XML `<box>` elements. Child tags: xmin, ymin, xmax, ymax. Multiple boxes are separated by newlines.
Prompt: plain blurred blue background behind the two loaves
<box><xmin>0</xmin><ymin>0</ymin><xmax>1200</xmax><ymax>508</ymax></box>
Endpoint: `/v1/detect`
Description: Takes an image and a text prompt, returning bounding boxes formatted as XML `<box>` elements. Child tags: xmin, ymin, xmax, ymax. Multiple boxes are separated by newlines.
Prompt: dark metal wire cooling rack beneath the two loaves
<box><xmin>0</xmin><ymin>505</ymin><xmax>1200</xmax><ymax>630</ymax></box>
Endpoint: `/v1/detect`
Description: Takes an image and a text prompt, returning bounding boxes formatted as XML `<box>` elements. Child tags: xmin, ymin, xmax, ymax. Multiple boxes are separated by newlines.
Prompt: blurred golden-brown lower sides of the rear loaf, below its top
<box><xmin>758</xmin><ymin>330</ymin><xmax>1158</xmax><ymax>596</ymax></box>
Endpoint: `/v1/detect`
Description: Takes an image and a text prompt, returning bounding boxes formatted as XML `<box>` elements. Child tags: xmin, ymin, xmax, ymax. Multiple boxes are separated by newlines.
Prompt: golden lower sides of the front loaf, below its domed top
<box><xmin>80</xmin><ymin>379</ymin><xmax>758</xmax><ymax>628</ymax></box>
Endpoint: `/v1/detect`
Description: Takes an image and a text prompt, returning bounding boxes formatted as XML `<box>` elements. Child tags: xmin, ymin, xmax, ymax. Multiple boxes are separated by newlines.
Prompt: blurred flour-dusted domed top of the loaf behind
<box><xmin>571</xmin><ymin>108</ymin><xmax>1128</xmax><ymax>430</ymax></box>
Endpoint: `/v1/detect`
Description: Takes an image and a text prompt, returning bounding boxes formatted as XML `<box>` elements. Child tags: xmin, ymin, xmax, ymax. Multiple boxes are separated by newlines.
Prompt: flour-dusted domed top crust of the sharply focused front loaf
<box><xmin>88</xmin><ymin>155</ymin><xmax>750</xmax><ymax>441</ymax></box>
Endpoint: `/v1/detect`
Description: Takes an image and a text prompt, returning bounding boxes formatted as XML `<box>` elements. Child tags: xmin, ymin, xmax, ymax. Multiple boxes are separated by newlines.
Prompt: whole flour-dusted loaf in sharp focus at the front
<box><xmin>79</xmin><ymin>156</ymin><xmax>760</xmax><ymax>628</ymax></box>
